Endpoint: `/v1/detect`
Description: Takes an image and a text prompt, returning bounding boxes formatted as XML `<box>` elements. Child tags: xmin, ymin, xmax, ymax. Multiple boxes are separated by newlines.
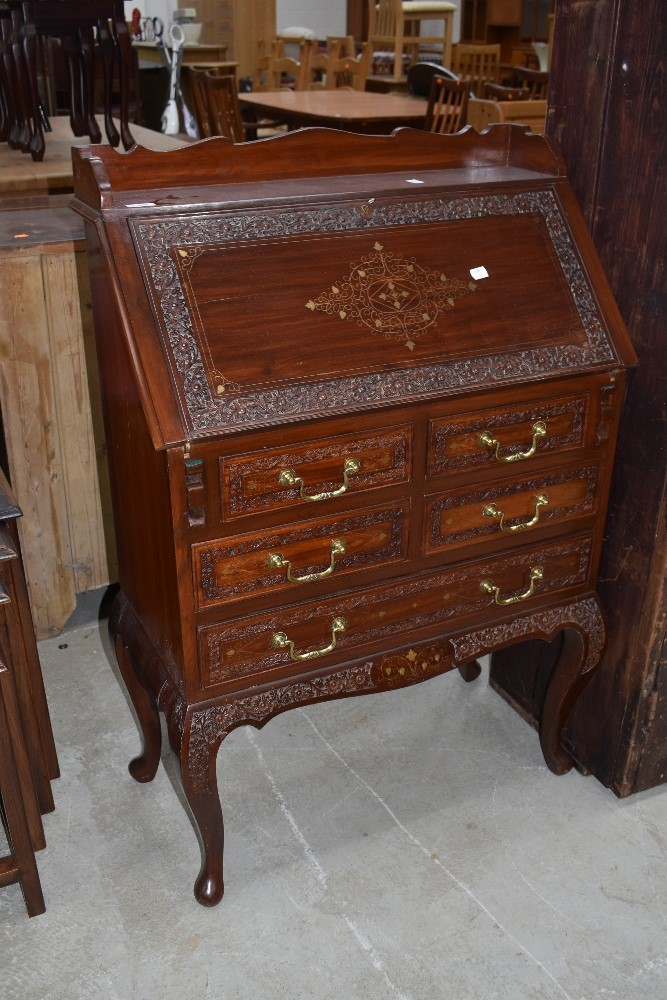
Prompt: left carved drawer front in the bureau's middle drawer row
<box><xmin>192</xmin><ymin>502</ymin><xmax>410</xmax><ymax>608</ymax></box>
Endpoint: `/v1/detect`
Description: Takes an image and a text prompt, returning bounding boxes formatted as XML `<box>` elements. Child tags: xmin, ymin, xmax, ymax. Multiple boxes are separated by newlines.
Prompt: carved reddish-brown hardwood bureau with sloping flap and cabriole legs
<box><xmin>73</xmin><ymin>126</ymin><xmax>635</xmax><ymax>905</ymax></box>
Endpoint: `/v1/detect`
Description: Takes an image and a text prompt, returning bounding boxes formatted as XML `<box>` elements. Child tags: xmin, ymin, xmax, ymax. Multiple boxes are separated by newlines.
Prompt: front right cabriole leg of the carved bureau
<box><xmin>539</xmin><ymin>628</ymin><xmax>592</xmax><ymax>774</ymax></box>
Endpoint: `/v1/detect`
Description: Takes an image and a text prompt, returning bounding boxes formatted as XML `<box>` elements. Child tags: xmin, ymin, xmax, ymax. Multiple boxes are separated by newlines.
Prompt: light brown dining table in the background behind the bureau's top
<box><xmin>239</xmin><ymin>90</ymin><xmax>427</xmax><ymax>135</ymax></box>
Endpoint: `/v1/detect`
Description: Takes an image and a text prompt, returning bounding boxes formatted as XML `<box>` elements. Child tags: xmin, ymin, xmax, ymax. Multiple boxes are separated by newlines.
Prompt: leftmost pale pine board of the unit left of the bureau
<box><xmin>0</xmin><ymin>254</ymin><xmax>76</xmax><ymax>637</ymax></box>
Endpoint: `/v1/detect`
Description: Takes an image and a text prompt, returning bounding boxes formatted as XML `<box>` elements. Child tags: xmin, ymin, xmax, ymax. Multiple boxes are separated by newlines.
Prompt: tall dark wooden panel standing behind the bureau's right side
<box><xmin>492</xmin><ymin>0</ymin><xmax>667</xmax><ymax>795</ymax></box>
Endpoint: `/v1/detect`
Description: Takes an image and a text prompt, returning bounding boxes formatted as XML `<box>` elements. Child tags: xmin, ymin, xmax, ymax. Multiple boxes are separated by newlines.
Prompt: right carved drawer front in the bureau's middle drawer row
<box><xmin>424</xmin><ymin>465</ymin><xmax>599</xmax><ymax>555</ymax></box>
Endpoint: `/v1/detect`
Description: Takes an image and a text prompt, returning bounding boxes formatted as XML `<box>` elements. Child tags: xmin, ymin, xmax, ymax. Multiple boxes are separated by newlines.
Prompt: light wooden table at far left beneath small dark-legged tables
<box><xmin>0</xmin><ymin>116</ymin><xmax>183</xmax><ymax>199</ymax></box>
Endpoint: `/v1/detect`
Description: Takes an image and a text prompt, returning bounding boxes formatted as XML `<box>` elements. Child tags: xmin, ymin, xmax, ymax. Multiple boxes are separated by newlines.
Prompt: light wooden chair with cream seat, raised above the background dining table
<box><xmin>368</xmin><ymin>0</ymin><xmax>457</xmax><ymax>81</ymax></box>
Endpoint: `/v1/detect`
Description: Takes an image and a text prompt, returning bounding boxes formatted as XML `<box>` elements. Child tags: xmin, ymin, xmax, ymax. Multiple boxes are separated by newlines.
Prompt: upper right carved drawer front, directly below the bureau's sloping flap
<box><xmin>428</xmin><ymin>394</ymin><xmax>590</xmax><ymax>476</ymax></box>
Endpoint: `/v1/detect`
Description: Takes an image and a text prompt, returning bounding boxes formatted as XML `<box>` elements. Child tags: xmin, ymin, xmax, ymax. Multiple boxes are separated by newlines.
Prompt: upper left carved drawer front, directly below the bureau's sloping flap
<box><xmin>220</xmin><ymin>427</ymin><xmax>412</xmax><ymax>518</ymax></box>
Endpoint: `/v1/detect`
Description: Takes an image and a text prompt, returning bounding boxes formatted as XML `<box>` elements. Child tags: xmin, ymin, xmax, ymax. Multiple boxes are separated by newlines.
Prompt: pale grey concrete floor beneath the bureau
<box><xmin>0</xmin><ymin>608</ymin><xmax>667</xmax><ymax>1000</ymax></box>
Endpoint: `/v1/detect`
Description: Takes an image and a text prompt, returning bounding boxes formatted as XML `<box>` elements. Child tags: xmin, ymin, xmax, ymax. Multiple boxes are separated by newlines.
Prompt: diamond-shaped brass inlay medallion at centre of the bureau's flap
<box><xmin>306</xmin><ymin>243</ymin><xmax>477</xmax><ymax>351</ymax></box>
